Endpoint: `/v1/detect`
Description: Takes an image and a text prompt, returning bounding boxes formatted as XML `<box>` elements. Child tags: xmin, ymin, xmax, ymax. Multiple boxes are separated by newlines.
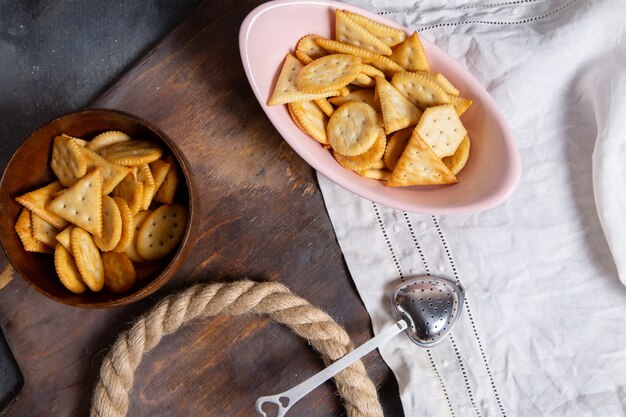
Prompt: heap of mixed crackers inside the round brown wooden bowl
<box><xmin>15</xmin><ymin>131</ymin><xmax>188</xmax><ymax>294</ymax></box>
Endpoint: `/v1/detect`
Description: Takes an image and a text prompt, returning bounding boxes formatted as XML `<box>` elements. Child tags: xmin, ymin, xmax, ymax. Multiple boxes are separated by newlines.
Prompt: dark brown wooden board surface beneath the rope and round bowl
<box><xmin>0</xmin><ymin>1</ymin><xmax>402</xmax><ymax>416</ymax></box>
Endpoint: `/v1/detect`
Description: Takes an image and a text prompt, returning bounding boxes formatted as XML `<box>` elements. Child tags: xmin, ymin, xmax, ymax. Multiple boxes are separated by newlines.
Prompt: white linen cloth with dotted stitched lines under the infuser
<box><xmin>319</xmin><ymin>0</ymin><xmax>626</xmax><ymax>417</ymax></box>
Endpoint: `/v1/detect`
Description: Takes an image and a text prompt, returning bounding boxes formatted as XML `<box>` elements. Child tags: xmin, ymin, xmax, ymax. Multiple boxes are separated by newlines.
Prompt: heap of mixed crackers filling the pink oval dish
<box><xmin>267</xmin><ymin>9</ymin><xmax>472</xmax><ymax>186</ymax></box>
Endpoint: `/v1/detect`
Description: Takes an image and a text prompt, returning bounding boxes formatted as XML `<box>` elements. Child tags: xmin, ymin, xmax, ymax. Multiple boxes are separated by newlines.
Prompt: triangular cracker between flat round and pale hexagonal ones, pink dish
<box><xmin>376</xmin><ymin>77</ymin><xmax>422</xmax><ymax>134</ymax></box>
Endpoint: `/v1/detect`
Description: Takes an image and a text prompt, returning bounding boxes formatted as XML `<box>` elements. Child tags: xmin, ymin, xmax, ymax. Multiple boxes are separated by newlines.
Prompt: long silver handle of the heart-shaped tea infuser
<box><xmin>255</xmin><ymin>320</ymin><xmax>407</xmax><ymax>417</ymax></box>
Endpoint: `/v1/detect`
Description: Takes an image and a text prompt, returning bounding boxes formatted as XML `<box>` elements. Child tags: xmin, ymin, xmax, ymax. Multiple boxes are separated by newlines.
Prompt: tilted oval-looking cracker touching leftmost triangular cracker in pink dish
<box><xmin>296</xmin><ymin>54</ymin><xmax>361</xmax><ymax>93</ymax></box>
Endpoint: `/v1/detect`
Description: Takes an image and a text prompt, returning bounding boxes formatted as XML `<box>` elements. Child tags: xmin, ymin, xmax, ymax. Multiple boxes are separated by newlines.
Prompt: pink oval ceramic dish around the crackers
<box><xmin>239</xmin><ymin>0</ymin><xmax>521</xmax><ymax>214</ymax></box>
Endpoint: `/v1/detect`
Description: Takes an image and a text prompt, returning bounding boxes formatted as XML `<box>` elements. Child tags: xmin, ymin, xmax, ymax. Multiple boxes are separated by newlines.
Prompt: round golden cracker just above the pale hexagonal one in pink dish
<box><xmin>391</xmin><ymin>72</ymin><xmax>450</xmax><ymax>110</ymax></box>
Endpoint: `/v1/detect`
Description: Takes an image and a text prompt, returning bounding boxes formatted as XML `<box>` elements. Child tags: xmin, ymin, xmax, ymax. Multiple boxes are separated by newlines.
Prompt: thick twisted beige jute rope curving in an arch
<box><xmin>91</xmin><ymin>280</ymin><xmax>383</xmax><ymax>417</ymax></box>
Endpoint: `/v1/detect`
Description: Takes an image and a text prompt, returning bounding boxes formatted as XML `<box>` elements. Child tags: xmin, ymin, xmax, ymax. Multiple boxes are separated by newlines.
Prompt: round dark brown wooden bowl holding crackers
<box><xmin>0</xmin><ymin>109</ymin><xmax>199</xmax><ymax>308</ymax></box>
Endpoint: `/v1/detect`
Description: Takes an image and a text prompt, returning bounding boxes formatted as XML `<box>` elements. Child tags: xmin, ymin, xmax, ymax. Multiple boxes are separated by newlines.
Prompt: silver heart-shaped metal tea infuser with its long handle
<box><xmin>256</xmin><ymin>275</ymin><xmax>465</xmax><ymax>417</ymax></box>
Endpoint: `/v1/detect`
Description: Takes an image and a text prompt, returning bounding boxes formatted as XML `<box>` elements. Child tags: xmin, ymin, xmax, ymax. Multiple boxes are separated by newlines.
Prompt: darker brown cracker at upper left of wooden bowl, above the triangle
<box><xmin>50</xmin><ymin>136</ymin><xmax>87</xmax><ymax>187</ymax></box>
